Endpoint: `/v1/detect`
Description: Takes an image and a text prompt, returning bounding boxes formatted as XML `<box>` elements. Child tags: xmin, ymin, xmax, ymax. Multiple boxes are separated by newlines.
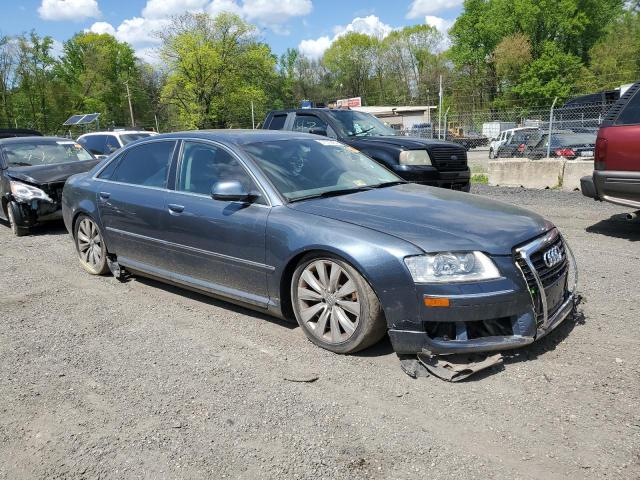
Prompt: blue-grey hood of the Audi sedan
<box><xmin>289</xmin><ymin>184</ymin><xmax>553</xmax><ymax>255</ymax></box>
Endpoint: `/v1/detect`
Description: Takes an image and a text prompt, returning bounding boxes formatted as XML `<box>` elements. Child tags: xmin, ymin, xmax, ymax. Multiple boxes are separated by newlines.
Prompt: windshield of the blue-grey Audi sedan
<box><xmin>244</xmin><ymin>139</ymin><xmax>404</xmax><ymax>201</ymax></box>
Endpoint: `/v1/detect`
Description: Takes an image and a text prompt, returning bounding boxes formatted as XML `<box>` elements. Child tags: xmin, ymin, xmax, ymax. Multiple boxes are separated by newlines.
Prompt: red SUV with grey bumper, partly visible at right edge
<box><xmin>580</xmin><ymin>82</ymin><xmax>640</xmax><ymax>213</ymax></box>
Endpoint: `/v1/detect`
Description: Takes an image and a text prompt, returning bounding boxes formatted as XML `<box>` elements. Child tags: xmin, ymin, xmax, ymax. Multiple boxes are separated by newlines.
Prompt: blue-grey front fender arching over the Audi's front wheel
<box><xmin>266</xmin><ymin>206</ymin><xmax>422</xmax><ymax>328</ymax></box>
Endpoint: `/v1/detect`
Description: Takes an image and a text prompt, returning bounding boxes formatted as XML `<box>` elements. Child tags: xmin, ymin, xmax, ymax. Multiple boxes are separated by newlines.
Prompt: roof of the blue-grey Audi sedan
<box><xmin>148</xmin><ymin>129</ymin><xmax>326</xmax><ymax>145</ymax></box>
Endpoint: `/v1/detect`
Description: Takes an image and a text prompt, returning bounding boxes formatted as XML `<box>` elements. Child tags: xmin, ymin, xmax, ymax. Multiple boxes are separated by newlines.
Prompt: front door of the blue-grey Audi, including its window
<box><xmin>166</xmin><ymin>141</ymin><xmax>272</xmax><ymax>306</ymax></box>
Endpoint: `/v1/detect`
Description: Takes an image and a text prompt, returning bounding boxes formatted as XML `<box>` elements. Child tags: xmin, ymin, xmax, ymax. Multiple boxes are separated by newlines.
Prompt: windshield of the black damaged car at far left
<box><xmin>3</xmin><ymin>140</ymin><xmax>93</xmax><ymax>167</ymax></box>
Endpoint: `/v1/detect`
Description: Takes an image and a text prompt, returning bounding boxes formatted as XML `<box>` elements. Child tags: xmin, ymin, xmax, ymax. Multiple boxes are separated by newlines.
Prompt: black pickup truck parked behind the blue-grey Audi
<box><xmin>262</xmin><ymin>108</ymin><xmax>470</xmax><ymax>192</ymax></box>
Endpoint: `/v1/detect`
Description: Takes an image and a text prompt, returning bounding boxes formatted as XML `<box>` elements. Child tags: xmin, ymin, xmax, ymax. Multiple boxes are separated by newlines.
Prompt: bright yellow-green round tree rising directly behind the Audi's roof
<box><xmin>161</xmin><ymin>13</ymin><xmax>276</xmax><ymax>128</ymax></box>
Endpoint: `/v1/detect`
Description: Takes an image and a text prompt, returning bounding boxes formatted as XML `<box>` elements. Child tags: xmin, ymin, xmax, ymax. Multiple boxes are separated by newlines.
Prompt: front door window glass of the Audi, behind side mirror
<box><xmin>177</xmin><ymin>142</ymin><xmax>256</xmax><ymax>196</ymax></box>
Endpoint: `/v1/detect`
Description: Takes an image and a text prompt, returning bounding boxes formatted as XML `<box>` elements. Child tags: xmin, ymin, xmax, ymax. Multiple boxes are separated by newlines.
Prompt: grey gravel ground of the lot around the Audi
<box><xmin>0</xmin><ymin>186</ymin><xmax>640</xmax><ymax>479</ymax></box>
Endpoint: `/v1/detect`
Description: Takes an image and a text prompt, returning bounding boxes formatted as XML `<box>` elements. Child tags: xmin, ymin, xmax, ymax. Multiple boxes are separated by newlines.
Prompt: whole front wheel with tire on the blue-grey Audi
<box><xmin>291</xmin><ymin>255</ymin><xmax>387</xmax><ymax>354</ymax></box>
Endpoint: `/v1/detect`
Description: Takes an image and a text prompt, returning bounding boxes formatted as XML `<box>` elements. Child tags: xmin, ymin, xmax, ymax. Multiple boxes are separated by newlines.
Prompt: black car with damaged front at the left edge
<box><xmin>0</xmin><ymin>136</ymin><xmax>98</xmax><ymax>236</ymax></box>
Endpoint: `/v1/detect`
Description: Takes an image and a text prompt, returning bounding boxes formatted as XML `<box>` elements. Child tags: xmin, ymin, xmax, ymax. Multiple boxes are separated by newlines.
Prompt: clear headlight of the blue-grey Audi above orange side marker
<box><xmin>404</xmin><ymin>252</ymin><xmax>500</xmax><ymax>283</ymax></box>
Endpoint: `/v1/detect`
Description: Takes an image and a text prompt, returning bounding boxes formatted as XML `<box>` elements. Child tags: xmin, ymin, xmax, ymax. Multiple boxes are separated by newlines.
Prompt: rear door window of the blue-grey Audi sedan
<box><xmin>111</xmin><ymin>141</ymin><xmax>175</xmax><ymax>188</ymax></box>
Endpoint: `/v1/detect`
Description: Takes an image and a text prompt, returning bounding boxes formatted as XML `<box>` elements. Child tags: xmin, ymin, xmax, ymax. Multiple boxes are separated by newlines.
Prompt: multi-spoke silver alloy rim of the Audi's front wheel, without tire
<box><xmin>297</xmin><ymin>259</ymin><xmax>362</xmax><ymax>344</ymax></box>
